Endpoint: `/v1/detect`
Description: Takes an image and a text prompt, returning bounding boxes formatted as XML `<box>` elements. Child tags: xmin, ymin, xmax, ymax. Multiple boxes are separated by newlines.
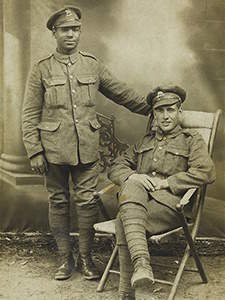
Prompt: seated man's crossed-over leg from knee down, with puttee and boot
<box><xmin>119</xmin><ymin>180</ymin><xmax>154</xmax><ymax>287</ymax></box>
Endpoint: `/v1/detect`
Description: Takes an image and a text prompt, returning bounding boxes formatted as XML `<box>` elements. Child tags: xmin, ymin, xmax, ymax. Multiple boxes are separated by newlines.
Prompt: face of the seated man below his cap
<box><xmin>153</xmin><ymin>104</ymin><xmax>182</xmax><ymax>133</ymax></box>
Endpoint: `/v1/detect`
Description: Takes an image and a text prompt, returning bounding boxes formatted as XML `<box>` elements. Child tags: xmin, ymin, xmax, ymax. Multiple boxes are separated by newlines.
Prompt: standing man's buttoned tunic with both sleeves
<box><xmin>22</xmin><ymin>51</ymin><xmax>150</xmax><ymax>165</ymax></box>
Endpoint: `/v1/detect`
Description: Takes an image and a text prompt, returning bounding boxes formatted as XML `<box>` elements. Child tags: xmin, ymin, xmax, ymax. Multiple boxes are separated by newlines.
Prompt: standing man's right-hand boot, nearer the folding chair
<box><xmin>77</xmin><ymin>254</ymin><xmax>100</xmax><ymax>280</ymax></box>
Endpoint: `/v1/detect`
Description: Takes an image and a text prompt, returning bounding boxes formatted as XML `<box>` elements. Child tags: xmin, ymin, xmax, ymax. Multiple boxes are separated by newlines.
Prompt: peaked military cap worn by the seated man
<box><xmin>147</xmin><ymin>86</ymin><xmax>186</xmax><ymax>108</ymax></box>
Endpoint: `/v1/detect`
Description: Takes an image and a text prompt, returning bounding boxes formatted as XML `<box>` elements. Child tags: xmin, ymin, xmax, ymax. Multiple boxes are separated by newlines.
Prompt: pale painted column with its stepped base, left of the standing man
<box><xmin>0</xmin><ymin>0</ymin><xmax>42</xmax><ymax>184</ymax></box>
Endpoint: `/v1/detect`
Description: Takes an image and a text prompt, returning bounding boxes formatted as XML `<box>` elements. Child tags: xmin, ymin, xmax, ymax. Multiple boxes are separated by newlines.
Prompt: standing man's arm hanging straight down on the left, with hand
<box><xmin>22</xmin><ymin>65</ymin><xmax>47</xmax><ymax>174</ymax></box>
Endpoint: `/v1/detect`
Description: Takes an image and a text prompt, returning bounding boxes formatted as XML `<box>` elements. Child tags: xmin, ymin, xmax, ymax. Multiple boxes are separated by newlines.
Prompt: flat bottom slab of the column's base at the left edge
<box><xmin>0</xmin><ymin>167</ymin><xmax>44</xmax><ymax>185</ymax></box>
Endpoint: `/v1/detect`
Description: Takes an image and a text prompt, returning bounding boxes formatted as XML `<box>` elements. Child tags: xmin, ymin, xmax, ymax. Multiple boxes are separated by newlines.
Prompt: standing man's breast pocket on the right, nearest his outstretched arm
<box><xmin>77</xmin><ymin>75</ymin><xmax>97</xmax><ymax>106</ymax></box>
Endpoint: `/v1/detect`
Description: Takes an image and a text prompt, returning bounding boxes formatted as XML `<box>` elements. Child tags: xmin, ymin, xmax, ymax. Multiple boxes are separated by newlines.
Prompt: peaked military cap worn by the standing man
<box><xmin>46</xmin><ymin>5</ymin><xmax>81</xmax><ymax>30</ymax></box>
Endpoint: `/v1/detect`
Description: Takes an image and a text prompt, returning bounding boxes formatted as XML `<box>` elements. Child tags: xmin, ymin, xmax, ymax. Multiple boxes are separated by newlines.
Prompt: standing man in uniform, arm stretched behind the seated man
<box><xmin>22</xmin><ymin>6</ymin><xmax>149</xmax><ymax>280</ymax></box>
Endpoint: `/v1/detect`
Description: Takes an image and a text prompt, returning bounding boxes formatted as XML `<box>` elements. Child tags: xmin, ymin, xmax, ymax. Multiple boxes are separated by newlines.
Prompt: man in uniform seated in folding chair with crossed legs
<box><xmin>109</xmin><ymin>86</ymin><xmax>215</xmax><ymax>299</ymax></box>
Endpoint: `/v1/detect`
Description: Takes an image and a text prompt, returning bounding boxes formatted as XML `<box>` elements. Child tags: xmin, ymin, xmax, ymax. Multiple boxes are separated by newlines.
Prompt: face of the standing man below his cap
<box><xmin>53</xmin><ymin>26</ymin><xmax>81</xmax><ymax>54</ymax></box>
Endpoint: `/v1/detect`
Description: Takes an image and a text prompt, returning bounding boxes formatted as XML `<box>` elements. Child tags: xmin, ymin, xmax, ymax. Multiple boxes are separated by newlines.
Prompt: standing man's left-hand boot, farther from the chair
<box><xmin>55</xmin><ymin>253</ymin><xmax>74</xmax><ymax>280</ymax></box>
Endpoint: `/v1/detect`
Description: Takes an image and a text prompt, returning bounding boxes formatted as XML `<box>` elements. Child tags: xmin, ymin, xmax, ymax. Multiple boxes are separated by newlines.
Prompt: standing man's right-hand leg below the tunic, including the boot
<box><xmin>71</xmin><ymin>162</ymin><xmax>99</xmax><ymax>279</ymax></box>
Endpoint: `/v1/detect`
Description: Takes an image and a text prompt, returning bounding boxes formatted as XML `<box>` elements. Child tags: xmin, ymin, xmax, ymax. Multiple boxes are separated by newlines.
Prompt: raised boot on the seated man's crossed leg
<box><xmin>131</xmin><ymin>258</ymin><xmax>154</xmax><ymax>289</ymax></box>
